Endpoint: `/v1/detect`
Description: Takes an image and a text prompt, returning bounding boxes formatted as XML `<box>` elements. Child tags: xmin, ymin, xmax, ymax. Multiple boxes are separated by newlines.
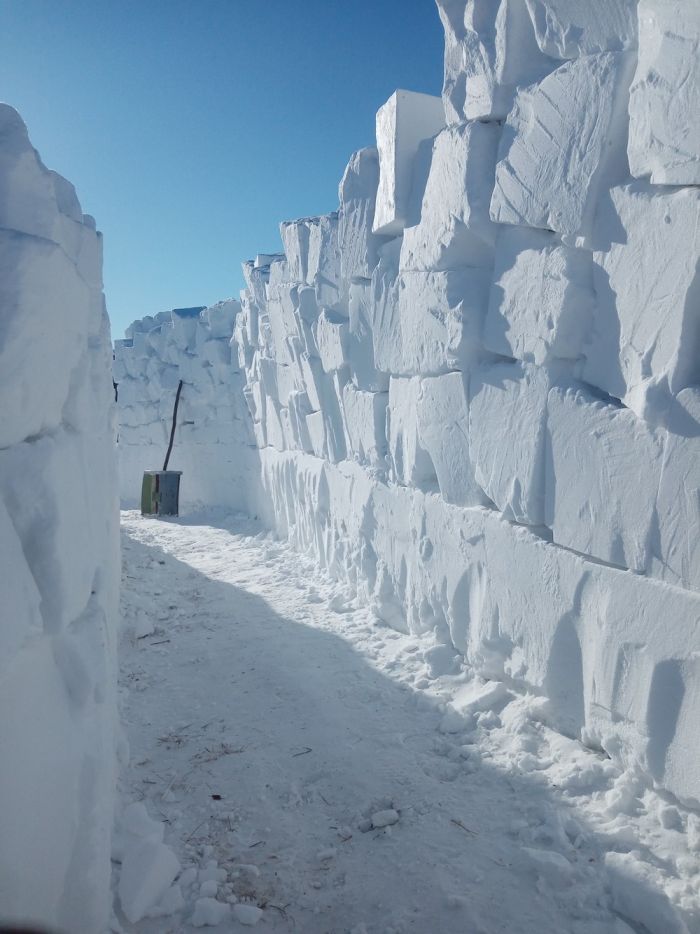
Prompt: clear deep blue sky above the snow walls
<box><xmin>0</xmin><ymin>0</ymin><xmax>443</xmax><ymax>337</ymax></box>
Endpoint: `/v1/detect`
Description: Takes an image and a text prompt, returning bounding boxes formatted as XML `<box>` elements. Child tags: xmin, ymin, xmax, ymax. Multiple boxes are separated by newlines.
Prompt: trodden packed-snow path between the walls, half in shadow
<box><xmin>114</xmin><ymin>512</ymin><xmax>700</xmax><ymax>934</ymax></box>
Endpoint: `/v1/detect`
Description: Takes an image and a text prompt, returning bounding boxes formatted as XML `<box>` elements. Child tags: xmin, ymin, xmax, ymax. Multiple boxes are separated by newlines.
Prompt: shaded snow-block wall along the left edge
<box><xmin>0</xmin><ymin>104</ymin><xmax>119</xmax><ymax>934</ymax></box>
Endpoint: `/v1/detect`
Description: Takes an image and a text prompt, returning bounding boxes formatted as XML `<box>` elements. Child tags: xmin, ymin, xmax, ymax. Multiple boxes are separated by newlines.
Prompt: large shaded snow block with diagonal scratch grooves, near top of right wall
<box><xmin>491</xmin><ymin>52</ymin><xmax>633</xmax><ymax>241</ymax></box>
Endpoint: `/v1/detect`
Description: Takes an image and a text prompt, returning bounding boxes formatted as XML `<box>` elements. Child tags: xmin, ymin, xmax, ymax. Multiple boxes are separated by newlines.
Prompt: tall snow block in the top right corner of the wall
<box><xmin>627</xmin><ymin>0</ymin><xmax>700</xmax><ymax>185</ymax></box>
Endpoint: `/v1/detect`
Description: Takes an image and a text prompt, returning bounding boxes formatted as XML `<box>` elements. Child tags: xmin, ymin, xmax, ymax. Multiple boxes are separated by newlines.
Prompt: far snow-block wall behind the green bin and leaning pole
<box><xmin>114</xmin><ymin>301</ymin><xmax>260</xmax><ymax>511</ymax></box>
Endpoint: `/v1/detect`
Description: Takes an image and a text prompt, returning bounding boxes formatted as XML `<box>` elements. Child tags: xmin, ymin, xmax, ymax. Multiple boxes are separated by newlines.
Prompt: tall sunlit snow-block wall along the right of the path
<box><xmin>235</xmin><ymin>0</ymin><xmax>700</xmax><ymax>803</ymax></box>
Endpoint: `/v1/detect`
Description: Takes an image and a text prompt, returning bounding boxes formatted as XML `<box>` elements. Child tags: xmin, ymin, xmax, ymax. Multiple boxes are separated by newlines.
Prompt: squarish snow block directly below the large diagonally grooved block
<box><xmin>483</xmin><ymin>227</ymin><xmax>595</xmax><ymax>365</ymax></box>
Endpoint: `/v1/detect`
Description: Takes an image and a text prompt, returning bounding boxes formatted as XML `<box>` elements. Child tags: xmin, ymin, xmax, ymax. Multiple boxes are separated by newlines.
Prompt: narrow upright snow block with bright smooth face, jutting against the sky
<box><xmin>372</xmin><ymin>90</ymin><xmax>445</xmax><ymax>237</ymax></box>
